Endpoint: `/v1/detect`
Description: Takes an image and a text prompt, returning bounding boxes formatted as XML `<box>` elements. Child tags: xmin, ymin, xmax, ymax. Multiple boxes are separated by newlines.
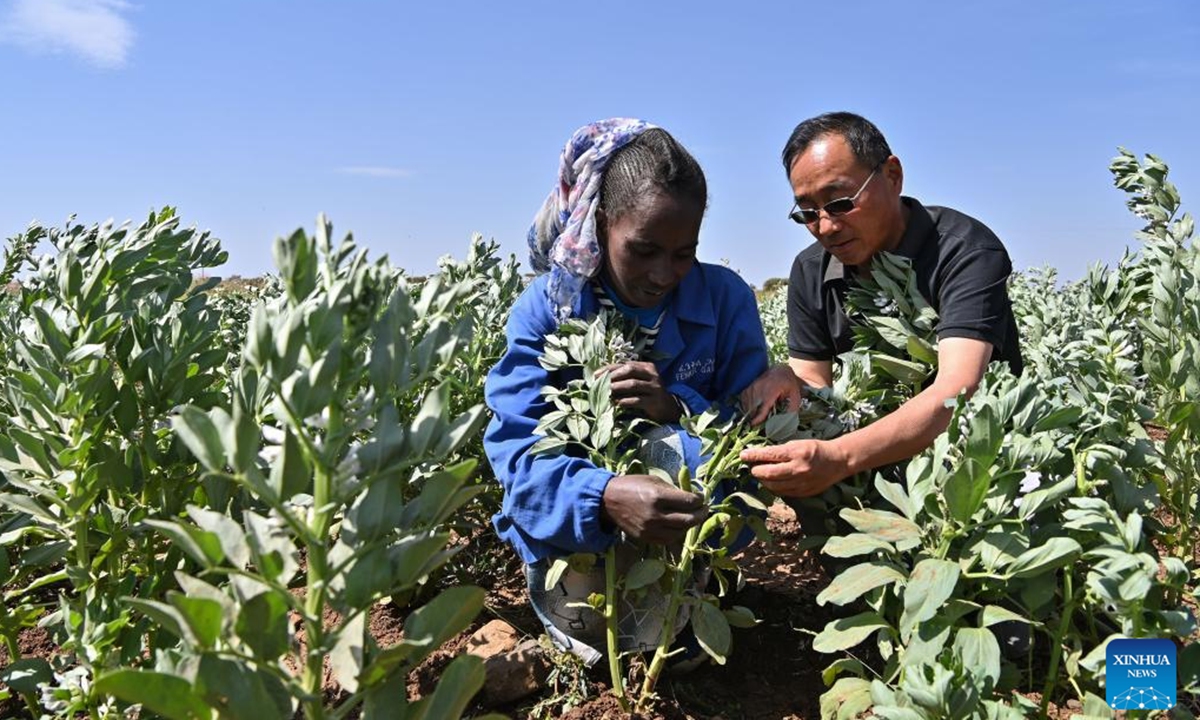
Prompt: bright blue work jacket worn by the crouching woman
<box><xmin>484</xmin><ymin>263</ymin><xmax>767</xmax><ymax>563</ymax></box>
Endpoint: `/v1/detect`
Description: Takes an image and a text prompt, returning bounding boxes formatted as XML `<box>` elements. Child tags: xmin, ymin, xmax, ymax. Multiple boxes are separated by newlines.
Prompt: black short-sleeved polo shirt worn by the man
<box><xmin>787</xmin><ymin>197</ymin><xmax>1024</xmax><ymax>374</ymax></box>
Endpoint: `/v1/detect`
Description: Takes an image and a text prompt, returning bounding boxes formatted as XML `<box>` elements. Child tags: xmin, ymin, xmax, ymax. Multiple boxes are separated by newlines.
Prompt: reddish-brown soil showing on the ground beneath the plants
<box><xmin>0</xmin><ymin>504</ymin><xmax>1195</xmax><ymax>720</ymax></box>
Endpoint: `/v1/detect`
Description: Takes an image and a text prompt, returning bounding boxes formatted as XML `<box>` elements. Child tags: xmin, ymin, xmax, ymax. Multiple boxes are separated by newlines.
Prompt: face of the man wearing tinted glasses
<box><xmin>788</xmin><ymin>134</ymin><xmax>904</xmax><ymax>265</ymax></box>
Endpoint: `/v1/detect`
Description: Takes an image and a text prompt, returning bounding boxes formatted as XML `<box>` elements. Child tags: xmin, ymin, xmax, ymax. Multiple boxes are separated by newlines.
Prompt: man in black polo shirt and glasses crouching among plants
<box><xmin>742</xmin><ymin>113</ymin><xmax>1022</xmax><ymax>497</ymax></box>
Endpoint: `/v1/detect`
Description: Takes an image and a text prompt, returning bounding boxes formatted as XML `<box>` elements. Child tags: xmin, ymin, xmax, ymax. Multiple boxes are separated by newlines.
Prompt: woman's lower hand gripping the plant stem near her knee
<box><xmin>601</xmin><ymin>475</ymin><xmax>708</xmax><ymax>545</ymax></box>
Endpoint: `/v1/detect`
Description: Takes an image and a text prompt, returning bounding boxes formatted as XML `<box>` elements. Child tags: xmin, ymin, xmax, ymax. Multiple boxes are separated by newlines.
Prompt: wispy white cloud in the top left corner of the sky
<box><xmin>0</xmin><ymin>0</ymin><xmax>134</xmax><ymax>70</ymax></box>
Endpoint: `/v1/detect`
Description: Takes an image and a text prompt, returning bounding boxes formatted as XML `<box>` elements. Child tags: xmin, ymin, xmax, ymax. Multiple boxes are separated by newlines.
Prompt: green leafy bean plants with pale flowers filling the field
<box><xmin>0</xmin><ymin>152</ymin><xmax>1200</xmax><ymax>720</ymax></box>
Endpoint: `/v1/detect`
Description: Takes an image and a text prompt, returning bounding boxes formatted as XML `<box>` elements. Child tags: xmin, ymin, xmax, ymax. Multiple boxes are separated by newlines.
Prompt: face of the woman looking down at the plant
<box><xmin>601</xmin><ymin>192</ymin><xmax>704</xmax><ymax>307</ymax></box>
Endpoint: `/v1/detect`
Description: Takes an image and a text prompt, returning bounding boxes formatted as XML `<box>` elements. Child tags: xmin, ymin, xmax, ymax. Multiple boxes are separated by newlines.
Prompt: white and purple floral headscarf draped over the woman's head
<box><xmin>529</xmin><ymin>118</ymin><xmax>654</xmax><ymax>322</ymax></box>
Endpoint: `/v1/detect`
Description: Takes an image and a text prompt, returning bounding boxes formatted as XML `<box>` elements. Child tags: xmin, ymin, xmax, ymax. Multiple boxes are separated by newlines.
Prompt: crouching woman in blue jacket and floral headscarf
<box><xmin>484</xmin><ymin>118</ymin><xmax>767</xmax><ymax>665</ymax></box>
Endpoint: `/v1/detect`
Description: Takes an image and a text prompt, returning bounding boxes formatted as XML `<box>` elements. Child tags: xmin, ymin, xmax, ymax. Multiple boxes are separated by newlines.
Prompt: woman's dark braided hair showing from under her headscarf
<box><xmin>600</xmin><ymin>127</ymin><xmax>708</xmax><ymax>221</ymax></box>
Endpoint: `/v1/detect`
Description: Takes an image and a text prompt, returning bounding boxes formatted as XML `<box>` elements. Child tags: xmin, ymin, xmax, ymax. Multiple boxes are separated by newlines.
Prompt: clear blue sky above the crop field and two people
<box><xmin>0</xmin><ymin>0</ymin><xmax>1200</xmax><ymax>284</ymax></box>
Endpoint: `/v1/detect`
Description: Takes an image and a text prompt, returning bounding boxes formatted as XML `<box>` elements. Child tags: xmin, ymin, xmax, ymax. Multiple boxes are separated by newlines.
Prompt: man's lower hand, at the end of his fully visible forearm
<box><xmin>742</xmin><ymin>440</ymin><xmax>853</xmax><ymax>498</ymax></box>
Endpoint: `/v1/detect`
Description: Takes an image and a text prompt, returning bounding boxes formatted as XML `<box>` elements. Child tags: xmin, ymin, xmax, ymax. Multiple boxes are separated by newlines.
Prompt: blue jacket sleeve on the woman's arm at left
<box><xmin>484</xmin><ymin>283</ymin><xmax>616</xmax><ymax>563</ymax></box>
